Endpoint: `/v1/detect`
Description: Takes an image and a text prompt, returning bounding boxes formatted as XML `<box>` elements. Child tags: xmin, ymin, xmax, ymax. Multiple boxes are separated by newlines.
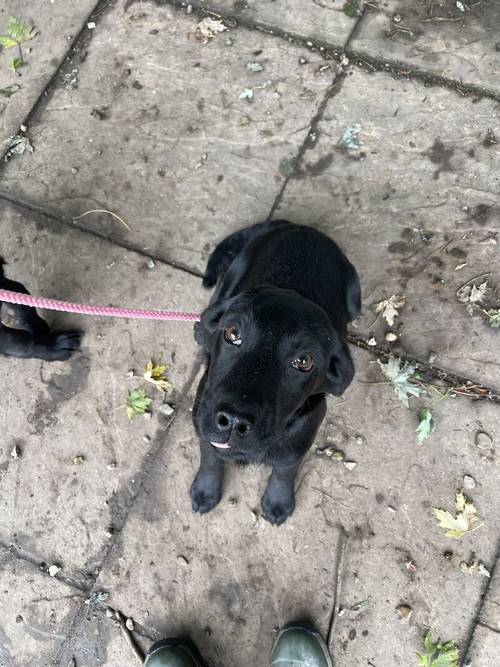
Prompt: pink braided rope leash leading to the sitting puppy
<box><xmin>0</xmin><ymin>289</ymin><xmax>200</xmax><ymax>322</ymax></box>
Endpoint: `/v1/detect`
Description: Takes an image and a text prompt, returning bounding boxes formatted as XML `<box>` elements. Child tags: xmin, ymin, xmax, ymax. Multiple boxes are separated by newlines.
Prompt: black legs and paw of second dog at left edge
<box><xmin>0</xmin><ymin>257</ymin><xmax>80</xmax><ymax>361</ymax></box>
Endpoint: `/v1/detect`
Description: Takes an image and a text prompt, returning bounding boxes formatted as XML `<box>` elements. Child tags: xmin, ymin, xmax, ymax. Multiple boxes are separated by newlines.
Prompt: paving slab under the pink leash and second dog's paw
<box><xmin>0</xmin><ymin>203</ymin><xmax>205</xmax><ymax>585</ymax></box>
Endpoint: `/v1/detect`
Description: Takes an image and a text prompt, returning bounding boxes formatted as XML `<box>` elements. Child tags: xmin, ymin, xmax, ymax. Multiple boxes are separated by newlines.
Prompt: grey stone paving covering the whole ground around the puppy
<box><xmin>0</xmin><ymin>0</ymin><xmax>500</xmax><ymax>667</ymax></box>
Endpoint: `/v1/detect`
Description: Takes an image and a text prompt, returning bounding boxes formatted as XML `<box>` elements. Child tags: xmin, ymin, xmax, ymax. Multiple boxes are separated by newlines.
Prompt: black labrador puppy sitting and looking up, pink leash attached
<box><xmin>191</xmin><ymin>220</ymin><xmax>361</xmax><ymax>524</ymax></box>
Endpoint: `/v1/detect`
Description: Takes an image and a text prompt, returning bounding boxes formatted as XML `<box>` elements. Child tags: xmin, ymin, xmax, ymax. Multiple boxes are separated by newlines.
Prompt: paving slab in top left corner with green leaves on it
<box><xmin>0</xmin><ymin>0</ymin><xmax>96</xmax><ymax>151</ymax></box>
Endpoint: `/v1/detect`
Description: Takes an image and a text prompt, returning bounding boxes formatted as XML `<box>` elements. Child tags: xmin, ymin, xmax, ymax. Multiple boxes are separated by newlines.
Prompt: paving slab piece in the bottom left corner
<box><xmin>0</xmin><ymin>548</ymin><xmax>83</xmax><ymax>667</ymax></box>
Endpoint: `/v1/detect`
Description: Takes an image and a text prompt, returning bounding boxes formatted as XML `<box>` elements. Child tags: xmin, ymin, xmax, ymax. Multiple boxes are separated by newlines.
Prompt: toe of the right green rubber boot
<box><xmin>269</xmin><ymin>623</ymin><xmax>333</xmax><ymax>667</ymax></box>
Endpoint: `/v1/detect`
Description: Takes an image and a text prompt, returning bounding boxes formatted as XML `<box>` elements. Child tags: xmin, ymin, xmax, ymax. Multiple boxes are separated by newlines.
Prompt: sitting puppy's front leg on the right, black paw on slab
<box><xmin>262</xmin><ymin>459</ymin><xmax>302</xmax><ymax>526</ymax></box>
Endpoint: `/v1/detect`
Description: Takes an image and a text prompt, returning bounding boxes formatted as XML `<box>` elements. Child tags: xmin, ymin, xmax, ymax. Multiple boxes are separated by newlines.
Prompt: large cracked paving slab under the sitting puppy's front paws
<box><xmin>84</xmin><ymin>350</ymin><xmax>500</xmax><ymax>667</ymax></box>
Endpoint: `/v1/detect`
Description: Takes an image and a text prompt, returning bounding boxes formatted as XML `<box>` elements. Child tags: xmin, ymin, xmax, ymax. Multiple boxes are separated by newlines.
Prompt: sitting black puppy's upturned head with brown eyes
<box><xmin>195</xmin><ymin>286</ymin><xmax>354</xmax><ymax>460</ymax></box>
